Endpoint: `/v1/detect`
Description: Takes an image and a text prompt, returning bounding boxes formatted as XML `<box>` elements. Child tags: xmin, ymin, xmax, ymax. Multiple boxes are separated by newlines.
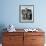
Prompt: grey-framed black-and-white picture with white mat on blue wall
<box><xmin>19</xmin><ymin>5</ymin><xmax>34</xmax><ymax>23</ymax></box>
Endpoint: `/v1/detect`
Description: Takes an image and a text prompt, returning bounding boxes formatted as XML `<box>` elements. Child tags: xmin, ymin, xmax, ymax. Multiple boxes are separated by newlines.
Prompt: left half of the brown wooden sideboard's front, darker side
<box><xmin>3</xmin><ymin>32</ymin><xmax>23</xmax><ymax>46</ymax></box>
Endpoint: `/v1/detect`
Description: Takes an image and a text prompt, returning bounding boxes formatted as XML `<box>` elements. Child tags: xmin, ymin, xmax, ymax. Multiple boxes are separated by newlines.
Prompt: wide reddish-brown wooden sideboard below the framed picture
<box><xmin>2</xmin><ymin>29</ymin><xmax>45</xmax><ymax>46</ymax></box>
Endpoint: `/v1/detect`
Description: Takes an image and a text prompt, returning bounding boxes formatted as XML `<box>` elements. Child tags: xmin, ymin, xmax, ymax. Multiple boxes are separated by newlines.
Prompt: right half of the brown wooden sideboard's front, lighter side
<box><xmin>24</xmin><ymin>32</ymin><xmax>44</xmax><ymax>46</ymax></box>
